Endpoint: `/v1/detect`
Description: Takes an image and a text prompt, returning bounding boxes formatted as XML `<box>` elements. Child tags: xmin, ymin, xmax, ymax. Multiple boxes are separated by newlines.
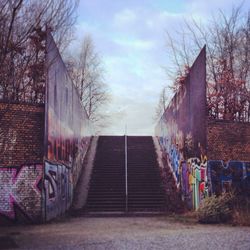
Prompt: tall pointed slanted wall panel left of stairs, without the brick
<box><xmin>45</xmin><ymin>33</ymin><xmax>91</xmax><ymax>220</ymax></box>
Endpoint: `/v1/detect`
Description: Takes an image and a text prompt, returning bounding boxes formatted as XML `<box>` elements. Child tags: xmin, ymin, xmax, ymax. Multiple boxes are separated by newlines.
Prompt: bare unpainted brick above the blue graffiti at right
<box><xmin>207</xmin><ymin>120</ymin><xmax>250</xmax><ymax>162</ymax></box>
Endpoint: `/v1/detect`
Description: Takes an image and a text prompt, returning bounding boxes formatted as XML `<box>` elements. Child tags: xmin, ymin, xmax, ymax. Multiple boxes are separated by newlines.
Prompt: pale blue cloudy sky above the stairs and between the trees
<box><xmin>75</xmin><ymin>0</ymin><xmax>250</xmax><ymax>135</ymax></box>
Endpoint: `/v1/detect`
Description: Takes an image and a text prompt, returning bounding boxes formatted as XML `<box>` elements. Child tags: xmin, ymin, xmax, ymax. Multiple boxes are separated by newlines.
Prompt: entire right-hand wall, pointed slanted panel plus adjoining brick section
<box><xmin>156</xmin><ymin>46</ymin><xmax>250</xmax><ymax>209</ymax></box>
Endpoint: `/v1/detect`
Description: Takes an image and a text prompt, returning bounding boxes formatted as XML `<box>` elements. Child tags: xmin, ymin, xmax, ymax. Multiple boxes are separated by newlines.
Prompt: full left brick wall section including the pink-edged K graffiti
<box><xmin>0</xmin><ymin>102</ymin><xmax>44</xmax><ymax>224</ymax></box>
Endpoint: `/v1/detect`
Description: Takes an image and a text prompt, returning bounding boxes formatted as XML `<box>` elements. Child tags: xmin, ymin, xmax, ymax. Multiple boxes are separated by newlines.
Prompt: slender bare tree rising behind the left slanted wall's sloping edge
<box><xmin>68</xmin><ymin>35</ymin><xmax>109</xmax><ymax>131</ymax></box>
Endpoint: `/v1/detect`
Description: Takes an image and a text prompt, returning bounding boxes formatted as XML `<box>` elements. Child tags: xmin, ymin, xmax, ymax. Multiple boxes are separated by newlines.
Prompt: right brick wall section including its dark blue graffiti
<box><xmin>207</xmin><ymin>120</ymin><xmax>250</xmax><ymax>195</ymax></box>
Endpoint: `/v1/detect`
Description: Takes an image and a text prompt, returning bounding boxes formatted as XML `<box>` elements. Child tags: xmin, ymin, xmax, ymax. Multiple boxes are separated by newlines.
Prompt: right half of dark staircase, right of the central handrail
<box><xmin>128</xmin><ymin>136</ymin><xmax>165</xmax><ymax>212</ymax></box>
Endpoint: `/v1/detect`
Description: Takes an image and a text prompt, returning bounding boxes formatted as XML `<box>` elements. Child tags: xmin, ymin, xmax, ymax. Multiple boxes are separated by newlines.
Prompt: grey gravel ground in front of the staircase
<box><xmin>0</xmin><ymin>217</ymin><xmax>250</xmax><ymax>250</ymax></box>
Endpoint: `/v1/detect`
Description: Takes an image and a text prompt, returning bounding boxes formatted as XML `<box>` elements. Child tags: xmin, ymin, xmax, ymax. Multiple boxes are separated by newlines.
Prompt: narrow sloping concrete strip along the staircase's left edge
<box><xmin>72</xmin><ymin>136</ymin><xmax>99</xmax><ymax>210</ymax></box>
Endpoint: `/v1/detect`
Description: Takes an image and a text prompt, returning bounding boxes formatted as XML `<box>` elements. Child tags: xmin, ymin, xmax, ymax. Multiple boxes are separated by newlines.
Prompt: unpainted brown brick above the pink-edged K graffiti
<box><xmin>0</xmin><ymin>103</ymin><xmax>44</xmax><ymax>167</ymax></box>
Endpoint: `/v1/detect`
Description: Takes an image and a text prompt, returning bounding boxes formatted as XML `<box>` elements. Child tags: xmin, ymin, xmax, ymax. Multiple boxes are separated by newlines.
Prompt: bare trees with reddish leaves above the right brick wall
<box><xmin>164</xmin><ymin>5</ymin><xmax>250</xmax><ymax>122</ymax></box>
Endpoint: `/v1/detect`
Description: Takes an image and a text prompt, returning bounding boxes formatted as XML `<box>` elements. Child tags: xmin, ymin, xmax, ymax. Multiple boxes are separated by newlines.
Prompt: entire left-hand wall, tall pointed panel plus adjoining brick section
<box><xmin>0</xmin><ymin>34</ymin><xmax>91</xmax><ymax>224</ymax></box>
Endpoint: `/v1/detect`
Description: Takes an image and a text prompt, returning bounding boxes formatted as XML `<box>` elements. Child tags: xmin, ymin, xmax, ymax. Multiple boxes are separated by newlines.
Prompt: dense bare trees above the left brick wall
<box><xmin>0</xmin><ymin>0</ymin><xmax>78</xmax><ymax>102</ymax></box>
